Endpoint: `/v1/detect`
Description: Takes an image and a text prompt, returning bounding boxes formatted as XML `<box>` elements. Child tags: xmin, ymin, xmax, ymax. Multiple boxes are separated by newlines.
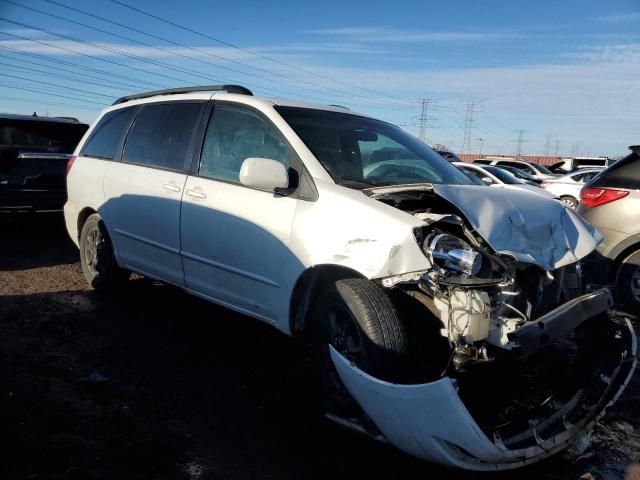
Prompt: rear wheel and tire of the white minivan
<box><xmin>80</xmin><ymin>213</ymin><xmax>130</xmax><ymax>290</ymax></box>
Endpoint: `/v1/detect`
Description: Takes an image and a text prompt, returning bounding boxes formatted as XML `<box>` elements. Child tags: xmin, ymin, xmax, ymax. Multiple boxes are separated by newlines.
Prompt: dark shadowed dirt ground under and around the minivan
<box><xmin>0</xmin><ymin>214</ymin><xmax>640</xmax><ymax>480</ymax></box>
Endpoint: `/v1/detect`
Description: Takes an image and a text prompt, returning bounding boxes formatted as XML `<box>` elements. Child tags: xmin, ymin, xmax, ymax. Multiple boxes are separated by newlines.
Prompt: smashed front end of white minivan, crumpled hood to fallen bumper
<box><xmin>330</xmin><ymin>185</ymin><xmax>637</xmax><ymax>470</ymax></box>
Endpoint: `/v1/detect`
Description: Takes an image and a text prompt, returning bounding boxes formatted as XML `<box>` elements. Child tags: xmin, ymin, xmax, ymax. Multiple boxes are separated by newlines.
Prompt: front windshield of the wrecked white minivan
<box><xmin>276</xmin><ymin>107</ymin><xmax>471</xmax><ymax>189</ymax></box>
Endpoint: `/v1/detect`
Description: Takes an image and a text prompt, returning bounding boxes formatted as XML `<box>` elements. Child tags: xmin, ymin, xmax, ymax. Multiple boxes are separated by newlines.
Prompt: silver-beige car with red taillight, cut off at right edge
<box><xmin>578</xmin><ymin>146</ymin><xmax>640</xmax><ymax>313</ymax></box>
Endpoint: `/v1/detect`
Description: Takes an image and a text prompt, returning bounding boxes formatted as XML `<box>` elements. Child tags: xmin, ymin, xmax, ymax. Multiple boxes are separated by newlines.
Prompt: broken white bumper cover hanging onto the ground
<box><xmin>330</xmin><ymin>319</ymin><xmax>637</xmax><ymax>471</ymax></box>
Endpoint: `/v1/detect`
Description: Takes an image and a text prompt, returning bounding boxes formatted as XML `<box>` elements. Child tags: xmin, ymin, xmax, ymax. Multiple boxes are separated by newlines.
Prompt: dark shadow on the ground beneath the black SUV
<box><xmin>0</xmin><ymin>212</ymin><xmax>79</xmax><ymax>271</ymax></box>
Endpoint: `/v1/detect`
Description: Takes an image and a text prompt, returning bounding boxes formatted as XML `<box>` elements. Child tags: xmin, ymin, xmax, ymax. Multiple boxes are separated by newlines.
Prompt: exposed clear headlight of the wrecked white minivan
<box><xmin>426</xmin><ymin>233</ymin><xmax>482</xmax><ymax>275</ymax></box>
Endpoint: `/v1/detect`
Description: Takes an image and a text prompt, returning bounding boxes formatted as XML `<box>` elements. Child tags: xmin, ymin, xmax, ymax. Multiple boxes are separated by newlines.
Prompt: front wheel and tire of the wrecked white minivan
<box><xmin>314</xmin><ymin>278</ymin><xmax>408</xmax><ymax>418</ymax></box>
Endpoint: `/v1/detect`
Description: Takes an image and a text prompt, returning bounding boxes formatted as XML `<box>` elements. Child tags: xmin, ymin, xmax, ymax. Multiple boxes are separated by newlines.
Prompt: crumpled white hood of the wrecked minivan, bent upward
<box><xmin>433</xmin><ymin>185</ymin><xmax>602</xmax><ymax>270</ymax></box>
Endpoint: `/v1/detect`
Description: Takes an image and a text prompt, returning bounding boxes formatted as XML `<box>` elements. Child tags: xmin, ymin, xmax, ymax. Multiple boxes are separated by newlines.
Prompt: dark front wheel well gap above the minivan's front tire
<box><xmin>289</xmin><ymin>265</ymin><xmax>364</xmax><ymax>335</ymax></box>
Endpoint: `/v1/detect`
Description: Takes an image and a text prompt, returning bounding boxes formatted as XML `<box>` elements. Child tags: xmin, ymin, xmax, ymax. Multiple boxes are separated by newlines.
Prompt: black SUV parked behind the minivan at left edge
<box><xmin>0</xmin><ymin>114</ymin><xmax>89</xmax><ymax>212</ymax></box>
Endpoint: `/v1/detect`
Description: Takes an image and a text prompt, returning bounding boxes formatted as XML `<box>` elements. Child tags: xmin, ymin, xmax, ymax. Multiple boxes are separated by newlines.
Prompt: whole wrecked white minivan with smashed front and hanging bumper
<box><xmin>65</xmin><ymin>86</ymin><xmax>636</xmax><ymax>470</ymax></box>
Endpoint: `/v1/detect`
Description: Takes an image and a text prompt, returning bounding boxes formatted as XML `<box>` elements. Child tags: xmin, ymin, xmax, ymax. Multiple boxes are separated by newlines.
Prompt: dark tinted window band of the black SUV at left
<box><xmin>0</xmin><ymin>120</ymin><xmax>89</xmax><ymax>152</ymax></box>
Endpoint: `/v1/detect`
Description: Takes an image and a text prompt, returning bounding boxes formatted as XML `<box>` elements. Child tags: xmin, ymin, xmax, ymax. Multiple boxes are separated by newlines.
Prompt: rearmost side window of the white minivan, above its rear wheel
<box><xmin>81</xmin><ymin>107</ymin><xmax>135</xmax><ymax>160</ymax></box>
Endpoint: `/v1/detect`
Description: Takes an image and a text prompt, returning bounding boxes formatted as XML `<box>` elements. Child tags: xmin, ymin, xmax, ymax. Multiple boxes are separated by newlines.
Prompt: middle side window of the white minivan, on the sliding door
<box><xmin>122</xmin><ymin>102</ymin><xmax>204</xmax><ymax>171</ymax></box>
